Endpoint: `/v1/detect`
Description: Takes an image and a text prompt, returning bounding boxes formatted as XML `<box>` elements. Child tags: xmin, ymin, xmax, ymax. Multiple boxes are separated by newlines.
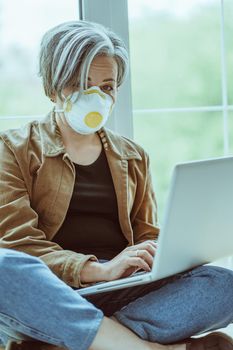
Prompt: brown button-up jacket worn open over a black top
<box><xmin>0</xmin><ymin>112</ymin><xmax>159</xmax><ymax>287</ymax></box>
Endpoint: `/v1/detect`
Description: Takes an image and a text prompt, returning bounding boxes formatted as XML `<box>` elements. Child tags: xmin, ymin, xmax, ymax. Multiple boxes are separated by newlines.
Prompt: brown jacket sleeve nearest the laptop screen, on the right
<box><xmin>132</xmin><ymin>153</ymin><xmax>159</xmax><ymax>244</ymax></box>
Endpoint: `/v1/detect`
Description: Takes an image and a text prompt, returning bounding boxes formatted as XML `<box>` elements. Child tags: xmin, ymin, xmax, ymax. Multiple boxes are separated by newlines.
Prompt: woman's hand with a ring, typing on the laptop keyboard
<box><xmin>102</xmin><ymin>240</ymin><xmax>157</xmax><ymax>281</ymax></box>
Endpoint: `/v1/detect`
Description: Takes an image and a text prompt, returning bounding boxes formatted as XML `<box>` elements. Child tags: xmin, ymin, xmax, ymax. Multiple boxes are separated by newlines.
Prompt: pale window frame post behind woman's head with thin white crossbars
<box><xmin>82</xmin><ymin>0</ymin><xmax>233</xmax><ymax>156</ymax></box>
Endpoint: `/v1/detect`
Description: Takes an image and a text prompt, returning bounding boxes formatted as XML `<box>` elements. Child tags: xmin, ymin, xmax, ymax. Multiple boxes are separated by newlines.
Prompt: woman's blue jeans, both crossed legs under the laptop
<box><xmin>0</xmin><ymin>249</ymin><xmax>233</xmax><ymax>350</ymax></box>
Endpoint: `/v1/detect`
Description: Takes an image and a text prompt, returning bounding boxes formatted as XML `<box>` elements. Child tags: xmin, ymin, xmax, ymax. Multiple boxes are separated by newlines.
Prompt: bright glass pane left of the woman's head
<box><xmin>0</xmin><ymin>0</ymin><xmax>79</xmax><ymax>117</ymax></box>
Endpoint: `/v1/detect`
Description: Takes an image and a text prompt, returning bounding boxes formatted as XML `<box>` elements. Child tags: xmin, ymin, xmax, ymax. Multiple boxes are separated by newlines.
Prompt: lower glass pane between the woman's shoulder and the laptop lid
<box><xmin>134</xmin><ymin>112</ymin><xmax>223</xmax><ymax>222</ymax></box>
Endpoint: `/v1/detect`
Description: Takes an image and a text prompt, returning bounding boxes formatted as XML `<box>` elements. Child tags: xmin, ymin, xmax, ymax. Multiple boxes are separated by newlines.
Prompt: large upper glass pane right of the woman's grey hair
<box><xmin>128</xmin><ymin>0</ymin><xmax>221</xmax><ymax>109</ymax></box>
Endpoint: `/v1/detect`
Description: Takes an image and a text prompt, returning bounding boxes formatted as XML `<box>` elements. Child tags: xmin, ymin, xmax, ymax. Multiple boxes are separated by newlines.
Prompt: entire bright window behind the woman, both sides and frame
<box><xmin>0</xmin><ymin>0</ymin><xmax>233</xmax><ymax>268</ymax></box>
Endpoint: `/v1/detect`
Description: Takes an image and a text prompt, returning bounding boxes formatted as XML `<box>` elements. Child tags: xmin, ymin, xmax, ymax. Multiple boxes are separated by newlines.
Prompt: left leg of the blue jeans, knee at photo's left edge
<box><xmin>0</xmin><ymin>249</ymin><xmax>103</xmax><ymax>350</ymax></box>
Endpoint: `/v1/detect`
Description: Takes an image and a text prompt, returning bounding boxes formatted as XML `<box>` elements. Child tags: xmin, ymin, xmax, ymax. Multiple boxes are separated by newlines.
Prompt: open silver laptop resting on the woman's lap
<box><xmin>77</xmin><ymin>157</ymin><xmax>233</xmax><ymax>295</ymax></box>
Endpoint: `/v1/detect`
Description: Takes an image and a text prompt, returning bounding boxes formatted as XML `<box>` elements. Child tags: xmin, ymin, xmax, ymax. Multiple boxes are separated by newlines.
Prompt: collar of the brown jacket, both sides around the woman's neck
<box><xmin>39</xmin><ymin>111</ymin><xmax>142</xmax><ymax>160</ymax></box>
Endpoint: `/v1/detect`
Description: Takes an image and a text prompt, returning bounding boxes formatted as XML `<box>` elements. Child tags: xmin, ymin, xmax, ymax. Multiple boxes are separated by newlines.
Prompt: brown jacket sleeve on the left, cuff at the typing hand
<box><xmin>0</xmin><ymin>138</ymin><xmax>97</xmax><ymax>287</ymax></box>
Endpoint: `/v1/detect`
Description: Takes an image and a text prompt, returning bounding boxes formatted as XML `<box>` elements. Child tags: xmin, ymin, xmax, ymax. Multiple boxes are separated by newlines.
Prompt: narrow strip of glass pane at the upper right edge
<box><xmin>224</xmin><ymin>0</ymin><xmax>233</xmax><ymax>104</ymax></box>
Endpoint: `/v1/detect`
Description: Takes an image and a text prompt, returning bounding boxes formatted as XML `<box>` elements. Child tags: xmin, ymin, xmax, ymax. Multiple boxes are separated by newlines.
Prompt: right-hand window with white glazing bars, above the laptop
<box><xmin>128</xmin><ymin>0</ymin><xmax>233</xmax><ymax>220</ymax></box>
